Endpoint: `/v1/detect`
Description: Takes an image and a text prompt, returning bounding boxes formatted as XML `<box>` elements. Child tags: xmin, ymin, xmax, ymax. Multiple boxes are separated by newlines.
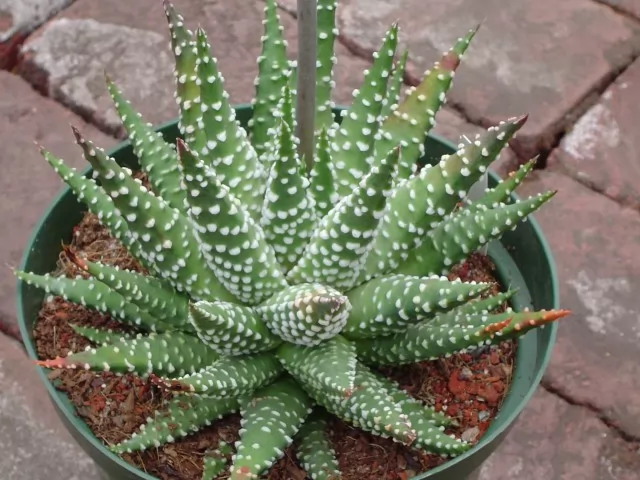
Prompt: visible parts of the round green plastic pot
<box><xmin>16</xmin><ymin>105</ymin><xmax>558</xmax><ymax>480</ymax></box>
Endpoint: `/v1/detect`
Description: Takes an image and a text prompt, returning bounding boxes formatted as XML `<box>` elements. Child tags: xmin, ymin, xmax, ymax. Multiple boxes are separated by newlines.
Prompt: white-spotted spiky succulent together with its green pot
<box><xmin>16</xmin><ymin>0</ymin><xmax>568</xmax><ymax>480</ymax></box>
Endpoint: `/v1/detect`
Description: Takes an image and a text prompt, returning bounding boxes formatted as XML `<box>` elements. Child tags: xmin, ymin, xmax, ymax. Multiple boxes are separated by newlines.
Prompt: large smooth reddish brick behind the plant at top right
<box><xmin>338</xmin><ymin>0</ymin><xmax>640</xmax><ymax>159</ymax></box>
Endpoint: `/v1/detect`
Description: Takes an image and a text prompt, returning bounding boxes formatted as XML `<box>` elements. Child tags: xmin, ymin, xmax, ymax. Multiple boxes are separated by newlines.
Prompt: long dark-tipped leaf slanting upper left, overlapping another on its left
<box><xmin>73</xmin><ymin>128</ymin><xmax>234</xmax><ymax>300</ymax></box>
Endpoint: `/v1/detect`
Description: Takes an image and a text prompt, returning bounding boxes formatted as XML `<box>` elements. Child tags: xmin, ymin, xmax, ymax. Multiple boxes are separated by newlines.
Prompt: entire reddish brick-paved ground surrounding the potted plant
<box><xmin>0</xmin><ymin>0</ymin><xmax>640</xmax><ymax>480</ymax></box>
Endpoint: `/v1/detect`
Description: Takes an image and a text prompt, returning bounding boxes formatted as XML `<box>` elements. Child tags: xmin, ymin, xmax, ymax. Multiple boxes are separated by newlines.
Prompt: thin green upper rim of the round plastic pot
<box><xmin>16</xmin><ymin>104</ymin><xmax>559</xmax><ymax>480</ymax></box>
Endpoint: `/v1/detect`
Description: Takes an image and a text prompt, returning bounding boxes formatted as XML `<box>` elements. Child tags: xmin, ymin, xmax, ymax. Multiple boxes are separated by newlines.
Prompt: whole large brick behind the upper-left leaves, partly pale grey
<box><xmin>20</xmin><ymin>0</ymin><xmax>369</xmax><ymax>137</ymax></box>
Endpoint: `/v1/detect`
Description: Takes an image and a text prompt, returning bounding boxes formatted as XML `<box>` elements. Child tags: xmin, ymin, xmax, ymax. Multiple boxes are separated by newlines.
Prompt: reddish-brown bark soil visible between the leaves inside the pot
<box><xmin>34</xmin><ymin>204</ymin><xmax>516</xmax><ymax>480</ymax></box>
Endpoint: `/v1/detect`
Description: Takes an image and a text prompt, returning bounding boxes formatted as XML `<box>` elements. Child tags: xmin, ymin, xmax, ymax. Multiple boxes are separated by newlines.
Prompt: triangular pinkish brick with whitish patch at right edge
<box><xmin>549</xmin><ymin>55</ymin><xmax>640</xmax><ymax>208</ymax></box>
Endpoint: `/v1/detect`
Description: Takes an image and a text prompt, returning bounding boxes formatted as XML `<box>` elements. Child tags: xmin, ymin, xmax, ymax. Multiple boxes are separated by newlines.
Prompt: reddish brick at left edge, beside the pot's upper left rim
<box><xmin>0</xmin><ymin>71</ymin><xmax>115</xmax><ymax>330</ymax></box>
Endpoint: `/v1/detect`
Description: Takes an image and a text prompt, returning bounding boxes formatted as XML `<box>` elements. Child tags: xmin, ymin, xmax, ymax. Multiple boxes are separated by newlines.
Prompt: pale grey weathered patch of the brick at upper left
<box><xmin>22</xmin><ymin>18</ymin><xmax>178</xmax><ymax>134</ymax></box>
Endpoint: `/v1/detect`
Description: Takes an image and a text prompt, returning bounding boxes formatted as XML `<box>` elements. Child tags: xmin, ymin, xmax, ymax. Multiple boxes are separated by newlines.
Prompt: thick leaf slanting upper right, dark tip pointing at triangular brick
<box><xmin>364</xmin><ymin>115</ymin><xmax>527</xmax><ymax>280</ymax></box>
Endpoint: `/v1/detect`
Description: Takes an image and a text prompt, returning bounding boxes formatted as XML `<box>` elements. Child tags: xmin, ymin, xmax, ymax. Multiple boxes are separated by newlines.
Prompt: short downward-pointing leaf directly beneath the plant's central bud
<box><xmin>276</xmin><ymin>335</ymin><xmax>356</xmax><ymax>396</ymax></box>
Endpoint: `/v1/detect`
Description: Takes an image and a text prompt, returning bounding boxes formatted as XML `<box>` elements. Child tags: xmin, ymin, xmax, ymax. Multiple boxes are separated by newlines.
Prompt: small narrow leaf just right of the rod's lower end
<box><xmin>309</xmin><ymin>129</ymin><xmax>338</xmax><ymax>219</ymax></box>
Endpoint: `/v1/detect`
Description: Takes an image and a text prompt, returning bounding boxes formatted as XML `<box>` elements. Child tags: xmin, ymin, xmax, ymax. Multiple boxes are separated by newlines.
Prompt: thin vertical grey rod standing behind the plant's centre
<box><xmin>296</xmin><ymin>0</ymin><xmax>318</xmax><ymax>169</ymax></box>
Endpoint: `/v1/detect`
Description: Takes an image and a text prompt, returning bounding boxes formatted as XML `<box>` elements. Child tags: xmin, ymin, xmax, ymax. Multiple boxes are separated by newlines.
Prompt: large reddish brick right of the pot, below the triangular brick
<box><xmin>519</xmin><ymin>169</ymin><xmax>640</xmax><ymax>437</ymax></box>
